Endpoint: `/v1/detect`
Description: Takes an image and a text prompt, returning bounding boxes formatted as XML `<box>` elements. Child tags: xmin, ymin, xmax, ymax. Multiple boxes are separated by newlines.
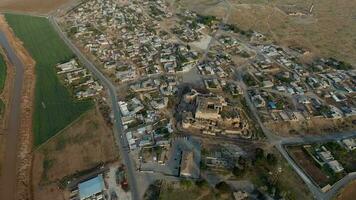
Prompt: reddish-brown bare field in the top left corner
<box><xmin>0</xmin><ymin>0</ymin><xmax>75</xmax><ymax>14</ymax></box>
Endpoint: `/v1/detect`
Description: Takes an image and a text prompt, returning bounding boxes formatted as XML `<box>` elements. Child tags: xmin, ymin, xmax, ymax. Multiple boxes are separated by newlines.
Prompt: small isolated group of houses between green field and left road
<box><xmin>56</xmin><ymin>59</ymin><xmax>103</xmax><ymax>99</ymax></box>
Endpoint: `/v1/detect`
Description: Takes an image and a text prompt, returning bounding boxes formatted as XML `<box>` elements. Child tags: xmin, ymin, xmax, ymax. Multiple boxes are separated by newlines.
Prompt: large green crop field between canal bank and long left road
<box><xmin>5</xmin><ymin>14</ymin><xmax>93</xmax><ymax>146</ymax></box>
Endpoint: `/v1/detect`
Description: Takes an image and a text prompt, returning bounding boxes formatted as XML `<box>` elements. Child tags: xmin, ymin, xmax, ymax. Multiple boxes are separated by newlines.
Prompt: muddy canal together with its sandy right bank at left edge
<box><xmin>0</xmin><ymin>15</ymin><xmax>35</xmax><ymax>200</ymax></box>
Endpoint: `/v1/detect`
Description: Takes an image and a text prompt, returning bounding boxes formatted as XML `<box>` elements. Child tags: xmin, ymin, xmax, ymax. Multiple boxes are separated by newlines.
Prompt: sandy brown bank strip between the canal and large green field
<box><xmin>0</xmin><ymin>15</ymin><xmax>35</xmax><ymax>199</ymax></box>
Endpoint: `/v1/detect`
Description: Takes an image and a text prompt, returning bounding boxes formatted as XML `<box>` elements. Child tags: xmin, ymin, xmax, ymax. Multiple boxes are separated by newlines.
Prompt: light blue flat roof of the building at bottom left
<box><xmin>78</xmin><ymin>174</ymin><xmax>105</xmax><ymax>200</ymax></box>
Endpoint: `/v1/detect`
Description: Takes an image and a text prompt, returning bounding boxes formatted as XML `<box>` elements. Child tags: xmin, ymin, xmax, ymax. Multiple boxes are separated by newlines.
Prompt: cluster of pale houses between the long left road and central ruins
<box><xmin>118</xmin><ymin>76</ymin><xmax>179</xmax><ymax>149</ymax></box>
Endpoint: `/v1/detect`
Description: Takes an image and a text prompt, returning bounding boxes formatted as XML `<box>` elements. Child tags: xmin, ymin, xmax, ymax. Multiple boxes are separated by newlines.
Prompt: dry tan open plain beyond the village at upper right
<box><xmin>180</xmin><ymin>0</ymin><xmax>356</xmax><ymax>63</ymax></box>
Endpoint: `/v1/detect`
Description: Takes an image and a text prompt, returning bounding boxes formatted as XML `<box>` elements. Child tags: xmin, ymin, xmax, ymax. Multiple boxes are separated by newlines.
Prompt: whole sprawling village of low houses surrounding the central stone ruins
<box><xmin>57</xmin><ymin>0</ymin><xmax>356</xmax><ymax>199</ymax></box>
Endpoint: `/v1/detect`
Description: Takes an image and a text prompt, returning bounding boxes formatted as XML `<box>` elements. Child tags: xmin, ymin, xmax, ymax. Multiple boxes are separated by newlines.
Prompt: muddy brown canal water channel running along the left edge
<box><xmin>0</xmin><ymin>31</ymin><xmax>24</xmax><ymax>200</ymax></box>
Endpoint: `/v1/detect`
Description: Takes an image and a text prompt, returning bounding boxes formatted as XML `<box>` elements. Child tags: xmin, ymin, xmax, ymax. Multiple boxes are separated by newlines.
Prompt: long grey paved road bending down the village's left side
<box><xmin>48</xmin><ymin>16</ymin><xmax>140</xmax><ymax>200</ymax></box>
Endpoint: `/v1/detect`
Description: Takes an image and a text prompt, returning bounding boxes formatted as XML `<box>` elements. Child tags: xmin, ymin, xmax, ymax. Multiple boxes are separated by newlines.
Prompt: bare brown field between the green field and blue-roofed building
<box><xmin>32</xmin><ymin>109</ymin><xmax>118</xmax><ymax>200</ymax></box>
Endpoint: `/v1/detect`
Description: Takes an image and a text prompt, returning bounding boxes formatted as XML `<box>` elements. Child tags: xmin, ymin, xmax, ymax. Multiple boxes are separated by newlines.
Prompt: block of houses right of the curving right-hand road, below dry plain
<box><xmin>244</xmin><ymin>44</ymin><xmax>356</xmax><ymax>123</ymax></box>
